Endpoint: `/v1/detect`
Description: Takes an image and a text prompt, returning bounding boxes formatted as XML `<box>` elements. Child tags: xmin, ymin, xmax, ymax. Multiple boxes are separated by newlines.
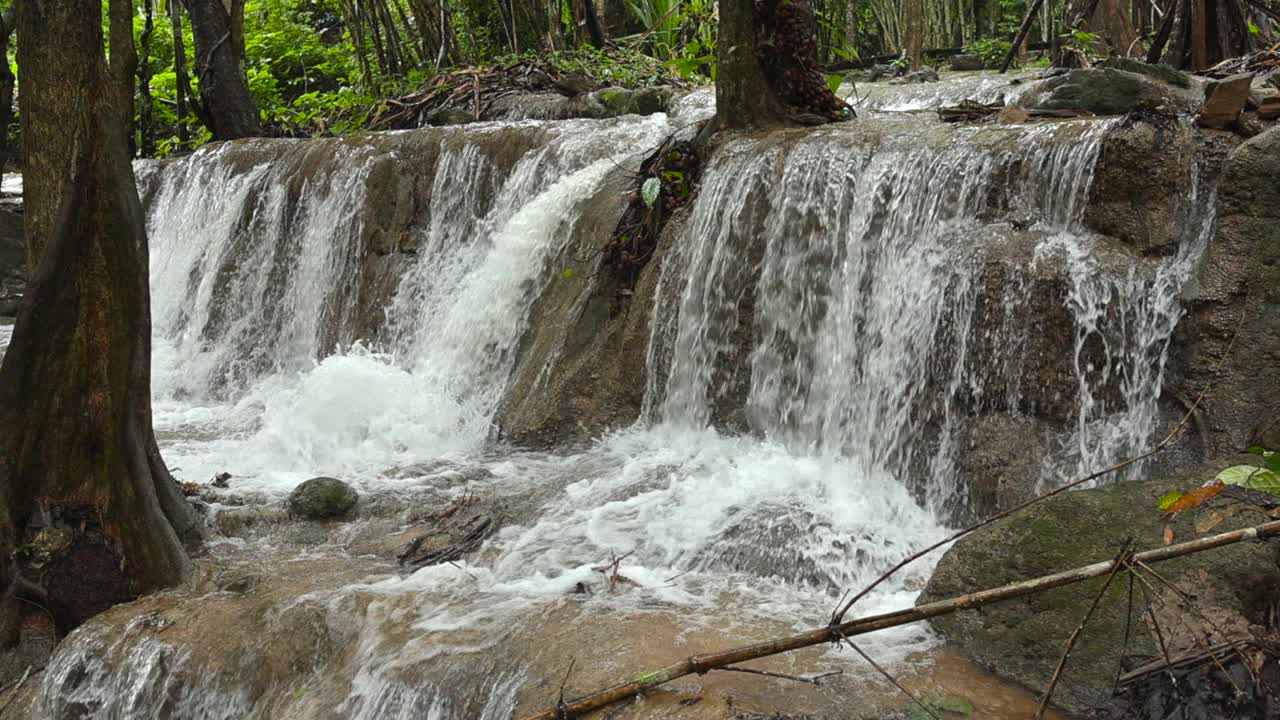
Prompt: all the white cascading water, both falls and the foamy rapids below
<box><xmin>22</xmin><ymin>75</ymin><xmax>1208</xmax><ymax>720</ymax></box>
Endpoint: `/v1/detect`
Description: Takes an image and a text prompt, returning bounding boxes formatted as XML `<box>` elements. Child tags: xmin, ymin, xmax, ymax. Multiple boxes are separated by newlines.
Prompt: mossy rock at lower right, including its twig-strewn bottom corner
<box><xmin>918</xmin><ymin>480</ymin><xmax>1280</xmax><ymax>720</ymax></box>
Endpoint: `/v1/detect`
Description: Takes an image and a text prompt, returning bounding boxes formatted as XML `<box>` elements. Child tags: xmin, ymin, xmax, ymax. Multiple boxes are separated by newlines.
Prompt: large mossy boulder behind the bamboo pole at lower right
<box><xmin>919</xmin><ymin>480</ymin><xmax>1280</xmax><ymax>714</ymax></box>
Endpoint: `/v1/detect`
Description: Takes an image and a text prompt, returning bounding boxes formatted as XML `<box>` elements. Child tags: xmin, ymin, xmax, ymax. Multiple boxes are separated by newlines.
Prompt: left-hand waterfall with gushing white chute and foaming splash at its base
<box><xmin>150</xmin><ymin>117</ymin><xmax>669</xmax><ymax>489</ymax></box>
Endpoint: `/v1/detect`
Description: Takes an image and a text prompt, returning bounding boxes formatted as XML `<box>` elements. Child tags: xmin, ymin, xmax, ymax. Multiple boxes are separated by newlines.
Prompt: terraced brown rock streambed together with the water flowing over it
<box><xmin>0</xmin><ymin>68</ymin><xmax>1280</xmax><ymax>720</ymax></box>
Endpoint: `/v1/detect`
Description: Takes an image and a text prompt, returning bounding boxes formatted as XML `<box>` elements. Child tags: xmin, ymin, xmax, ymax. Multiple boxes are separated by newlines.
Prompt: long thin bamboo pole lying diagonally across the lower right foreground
<box><xmin>526</xmin><ymin>520</ymin><xmax>1280</xmax><ymax>720</ymax></box>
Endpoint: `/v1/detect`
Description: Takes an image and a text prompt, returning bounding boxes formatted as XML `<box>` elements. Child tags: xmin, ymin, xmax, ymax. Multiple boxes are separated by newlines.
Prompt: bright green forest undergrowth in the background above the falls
<box><xmin>10</xmin><ymin>0</ymin><xmax>1249</xmax><ymax>156</ymax></box>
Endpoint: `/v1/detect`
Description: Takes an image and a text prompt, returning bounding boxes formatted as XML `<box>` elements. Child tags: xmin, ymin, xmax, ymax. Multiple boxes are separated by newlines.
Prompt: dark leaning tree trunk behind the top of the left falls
<box><xmin>187</xmin><ymin>0</ymin><xmax>262</xmax><ymax>140</ymax></box>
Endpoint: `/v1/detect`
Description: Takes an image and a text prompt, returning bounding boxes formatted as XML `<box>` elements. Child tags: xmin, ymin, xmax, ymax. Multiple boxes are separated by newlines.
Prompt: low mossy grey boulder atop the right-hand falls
<box><xmin>1021</xmin><ymin>68</ymin><xmax>1197</xmax><ymax>115</ymax></box>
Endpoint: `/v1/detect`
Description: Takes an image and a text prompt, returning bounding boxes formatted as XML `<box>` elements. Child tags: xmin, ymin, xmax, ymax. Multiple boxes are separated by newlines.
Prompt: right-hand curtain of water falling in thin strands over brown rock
<box><xmin>650</xmin><ymin>123</ymin><xmax>1131</xmax><ymax>507</ymax></box>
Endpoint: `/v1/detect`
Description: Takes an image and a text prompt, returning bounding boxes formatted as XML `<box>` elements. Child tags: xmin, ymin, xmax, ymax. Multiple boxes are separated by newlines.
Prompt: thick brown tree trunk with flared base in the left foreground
<box><xmin>0</xmin><ymin>0</ymin><xmax>198</xmax><ymax>642</ymax></box>
